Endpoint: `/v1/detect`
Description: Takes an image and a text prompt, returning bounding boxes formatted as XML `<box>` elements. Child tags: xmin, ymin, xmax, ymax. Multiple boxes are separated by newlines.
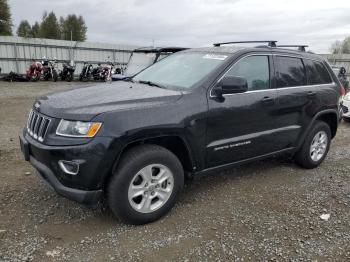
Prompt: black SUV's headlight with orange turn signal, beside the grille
<box><xmin>56</xmin><ymin>119</ymin><xmax>102</xmax><ymax>137</ymax></box>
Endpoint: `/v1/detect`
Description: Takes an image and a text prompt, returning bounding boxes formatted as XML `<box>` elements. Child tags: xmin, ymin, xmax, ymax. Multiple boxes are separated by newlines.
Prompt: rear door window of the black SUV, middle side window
<box><xmin>275</xmin><ymin>56</ymin><xmax>306</xmax><ymax>88</ymax></box>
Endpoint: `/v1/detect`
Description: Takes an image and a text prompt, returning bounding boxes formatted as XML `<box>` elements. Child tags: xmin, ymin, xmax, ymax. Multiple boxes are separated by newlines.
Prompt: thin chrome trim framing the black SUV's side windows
<box><xmin>209</xmin><ymin>53</ymin><xmax>336</xmax><ymax>98</ymax></box>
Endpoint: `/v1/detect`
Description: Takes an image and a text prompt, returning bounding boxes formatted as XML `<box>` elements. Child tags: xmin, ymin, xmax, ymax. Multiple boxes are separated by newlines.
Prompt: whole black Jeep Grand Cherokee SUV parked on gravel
<box><xmin>20</xmin><ymin>42</ymin><xmax>341</xmax><ymax>224</ymax></box>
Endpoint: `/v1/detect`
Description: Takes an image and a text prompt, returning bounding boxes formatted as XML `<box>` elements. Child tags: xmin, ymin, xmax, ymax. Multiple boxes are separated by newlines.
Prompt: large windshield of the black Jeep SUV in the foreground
<box><xmin>133</xmin><ymin>53</ymin><xmax>227</xmax><ymax>90</ymax></box>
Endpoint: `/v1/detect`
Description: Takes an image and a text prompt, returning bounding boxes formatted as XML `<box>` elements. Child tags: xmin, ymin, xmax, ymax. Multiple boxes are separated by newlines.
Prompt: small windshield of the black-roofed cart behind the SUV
<box><xmin>125</xmin><ymin>52</ymin><xmax>157</xmax><ymax>76</ymax></box>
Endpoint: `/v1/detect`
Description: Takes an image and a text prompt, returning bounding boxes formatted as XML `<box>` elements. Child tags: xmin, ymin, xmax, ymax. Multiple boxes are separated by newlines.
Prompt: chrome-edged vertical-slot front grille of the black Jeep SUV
<box><xmin>27</xmin><ymin>110</ymin><xmax>51</xmax><ymax>142</ymax></box>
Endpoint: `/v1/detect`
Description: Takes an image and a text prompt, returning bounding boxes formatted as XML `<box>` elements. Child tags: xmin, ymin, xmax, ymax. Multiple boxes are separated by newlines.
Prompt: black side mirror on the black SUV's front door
<box><xmin>213</xmin><ymin>76</ymin><xmax>248</xmax><ymax>97</ymax></box>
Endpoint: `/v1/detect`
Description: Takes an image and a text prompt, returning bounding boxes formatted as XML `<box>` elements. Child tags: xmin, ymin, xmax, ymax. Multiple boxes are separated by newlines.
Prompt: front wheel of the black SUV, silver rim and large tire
<box><xmin>107</xmin><ymin>145</ymin><xmax>184</xmax><ymax>225</ymax></box>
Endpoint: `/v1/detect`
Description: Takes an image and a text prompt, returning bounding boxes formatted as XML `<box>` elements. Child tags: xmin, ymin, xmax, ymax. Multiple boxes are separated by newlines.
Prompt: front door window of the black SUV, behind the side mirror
<box><xmin>226</xmin><ymin>56</ymin><xmax>270</xmax><ymax>90</ymax></box>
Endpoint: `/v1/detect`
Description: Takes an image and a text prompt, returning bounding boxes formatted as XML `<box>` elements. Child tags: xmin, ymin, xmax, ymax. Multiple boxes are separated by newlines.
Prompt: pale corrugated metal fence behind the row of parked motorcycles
<box><xmin>0</xmin><ymin>36</ymin><xmax>137</xmax><ymax>74</ymax></box>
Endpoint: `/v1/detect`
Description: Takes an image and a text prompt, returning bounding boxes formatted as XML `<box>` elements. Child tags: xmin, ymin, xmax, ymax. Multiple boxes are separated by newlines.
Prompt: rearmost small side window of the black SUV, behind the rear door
<box><xmin>304</xmin><ymin>59</ymin><xmax>332</xmax><ymax>85</ymax></box>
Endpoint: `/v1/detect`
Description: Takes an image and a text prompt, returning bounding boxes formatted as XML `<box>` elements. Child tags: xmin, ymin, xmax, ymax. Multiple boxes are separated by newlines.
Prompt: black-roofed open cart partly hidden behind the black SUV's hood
<box><xmin>112</xmin><ymin>47</ymin><xmax>186</xmax><ymax>81</ymax></box>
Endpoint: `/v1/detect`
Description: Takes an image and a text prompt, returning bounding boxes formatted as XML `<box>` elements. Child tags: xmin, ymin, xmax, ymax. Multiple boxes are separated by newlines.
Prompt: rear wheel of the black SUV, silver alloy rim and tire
<box><xmin>295</xmin><ymin>120</ymin><xmax>331</xmax><ymax>169</ymax></box>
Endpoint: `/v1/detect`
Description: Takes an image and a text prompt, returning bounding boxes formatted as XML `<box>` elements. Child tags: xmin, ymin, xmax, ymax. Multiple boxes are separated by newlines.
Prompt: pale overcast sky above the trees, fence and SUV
<box><xmin>9</xmin><ymin>0</ymin><xmax>350</xmax><ymax>53</ymax></box>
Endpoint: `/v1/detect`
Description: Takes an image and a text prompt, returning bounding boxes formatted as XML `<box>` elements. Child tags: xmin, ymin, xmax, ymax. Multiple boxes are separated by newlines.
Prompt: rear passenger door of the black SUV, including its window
<box><xmin>274</xmin><ymin>55</ymin><xmax>317</xmax><ymax>149</ymax></box>
